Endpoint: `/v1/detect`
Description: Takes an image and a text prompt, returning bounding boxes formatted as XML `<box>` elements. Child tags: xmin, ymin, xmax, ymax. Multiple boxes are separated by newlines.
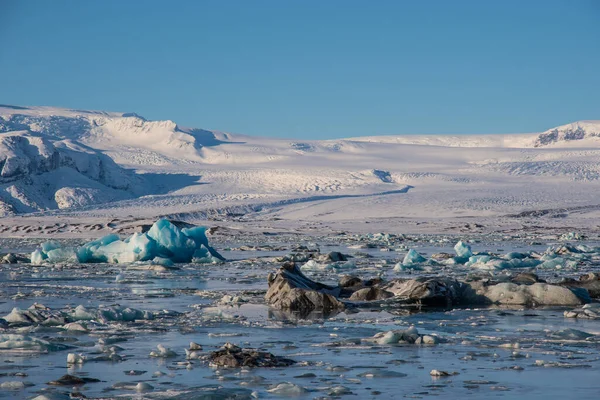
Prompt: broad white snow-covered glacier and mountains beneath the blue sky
<box><xmin>0</xmin><ymin>106</ymin><xmax>600</xmax><ymax>234</ymax></box>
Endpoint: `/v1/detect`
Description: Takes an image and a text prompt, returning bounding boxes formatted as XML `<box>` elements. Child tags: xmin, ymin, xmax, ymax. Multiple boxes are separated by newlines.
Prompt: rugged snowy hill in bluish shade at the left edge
<box><xmin>0</xmin><ymin>131</ymin><xmax>142</xmax><ymax>215</ymax></box>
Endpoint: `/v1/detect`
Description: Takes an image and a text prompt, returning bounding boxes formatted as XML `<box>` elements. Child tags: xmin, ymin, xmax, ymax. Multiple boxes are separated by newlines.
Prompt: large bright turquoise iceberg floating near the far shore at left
<box><xmin>31</xmin><ymin>219</ymin><xmax>225</xmax><ymax>267</ymax></box>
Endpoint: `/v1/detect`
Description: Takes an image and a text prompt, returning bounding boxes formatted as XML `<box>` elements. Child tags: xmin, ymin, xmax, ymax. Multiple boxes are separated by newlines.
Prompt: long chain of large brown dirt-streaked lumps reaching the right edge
<box><xmin>265</xmin><ymin>262</ymin><xmax>600</xmax><ymax>314</ymax></box>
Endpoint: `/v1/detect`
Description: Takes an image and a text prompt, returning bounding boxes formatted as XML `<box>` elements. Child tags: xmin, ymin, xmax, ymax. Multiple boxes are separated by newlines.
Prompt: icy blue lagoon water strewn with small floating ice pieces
<box><xmin>0</xmin><ymin>235</ymin><xmax>600</xmax><ymax>399</ymax></box>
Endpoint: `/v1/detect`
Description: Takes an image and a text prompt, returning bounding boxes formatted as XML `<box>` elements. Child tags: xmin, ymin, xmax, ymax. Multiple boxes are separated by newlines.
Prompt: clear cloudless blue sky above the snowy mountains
<box><xmin>0</xmin><ymin>0</ymin><xmax>600</xmax><ymax>138</ymax></box>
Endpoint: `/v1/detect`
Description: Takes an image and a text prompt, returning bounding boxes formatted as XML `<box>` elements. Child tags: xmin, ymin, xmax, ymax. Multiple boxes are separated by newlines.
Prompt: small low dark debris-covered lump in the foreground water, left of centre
<box><xmin>208</xmin><ymin>343</ymin><xmax>296</xmax><ymax>368</ymax></box>
